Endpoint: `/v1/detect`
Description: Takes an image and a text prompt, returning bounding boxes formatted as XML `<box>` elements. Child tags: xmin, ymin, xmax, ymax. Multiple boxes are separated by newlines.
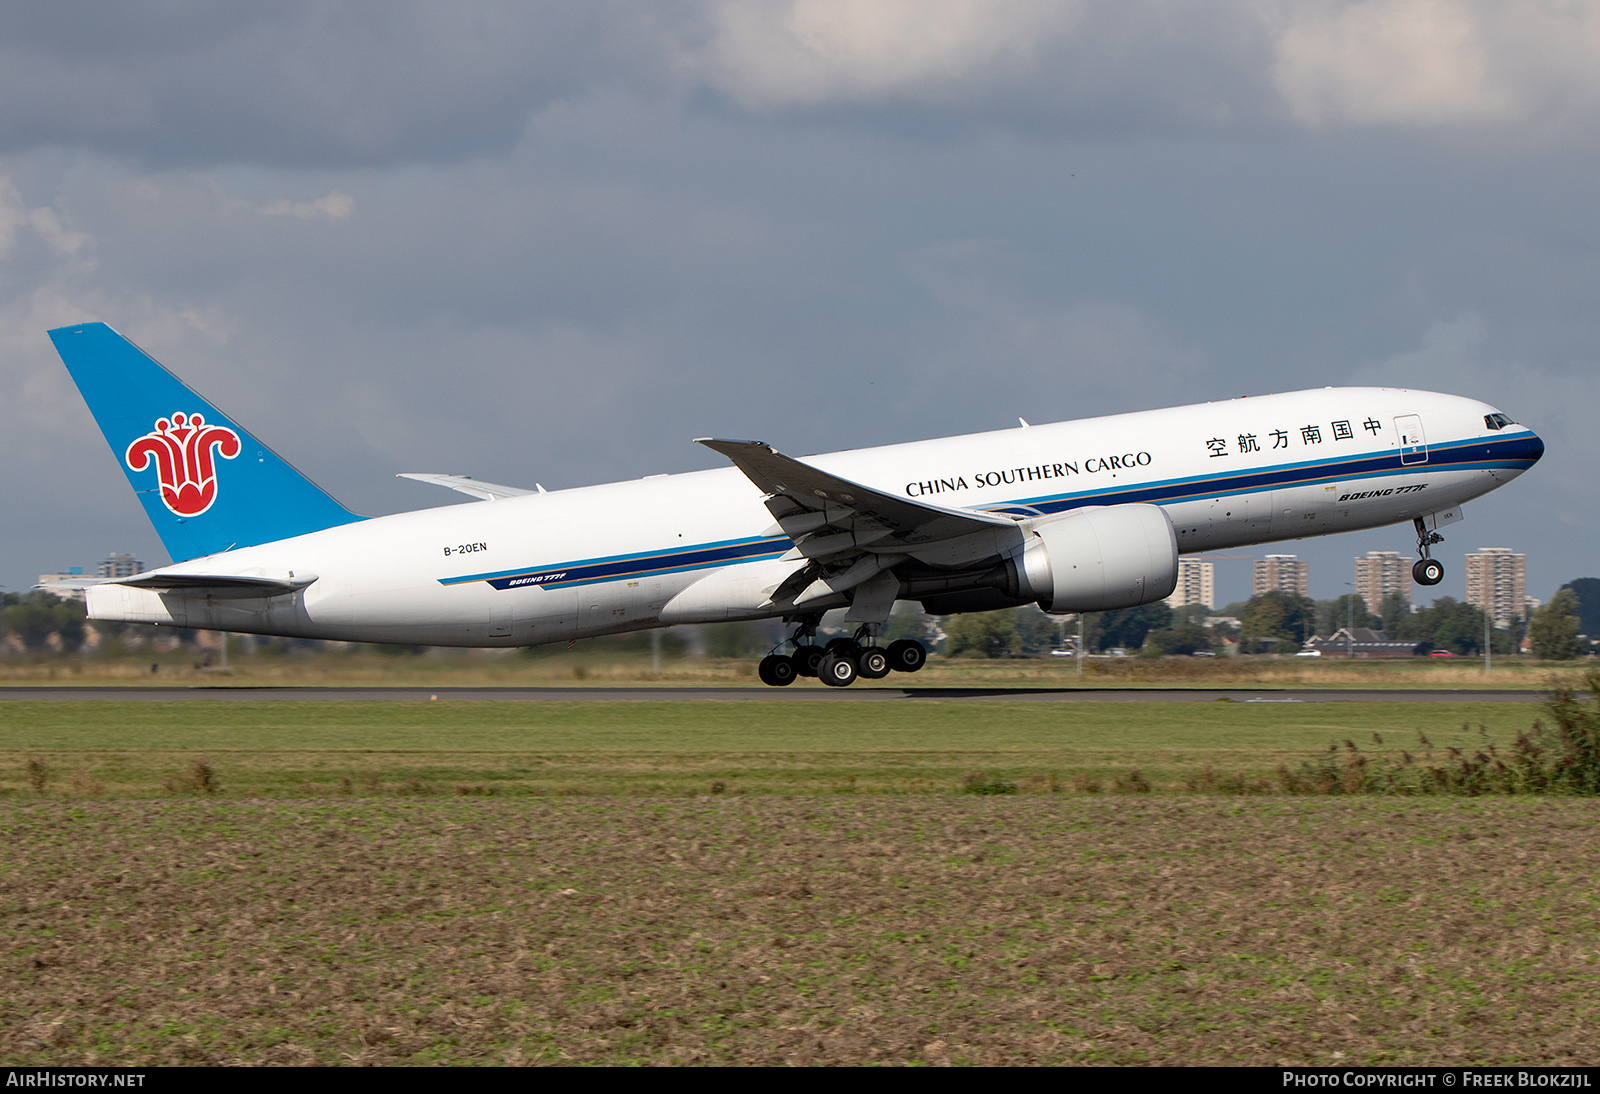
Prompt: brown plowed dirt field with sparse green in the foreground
<box><xmin>0</xmin><ymin>793</ymin><xmax>1600</xmax><ymax>1065</ymax></box>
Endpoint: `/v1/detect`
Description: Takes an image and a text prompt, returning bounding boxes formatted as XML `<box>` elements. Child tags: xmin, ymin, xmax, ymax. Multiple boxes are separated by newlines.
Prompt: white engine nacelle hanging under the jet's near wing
<box><xmin>1006</xmin><ymin>505</ymin><xmax>1178</xmax><ymax>613</ymax></box>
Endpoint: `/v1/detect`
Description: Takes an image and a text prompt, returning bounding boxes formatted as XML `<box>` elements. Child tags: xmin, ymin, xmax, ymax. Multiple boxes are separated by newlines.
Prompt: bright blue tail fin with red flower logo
<box><xmin>50</xmin><ymin>323</ymin><xmax>362</xmax><ymax>561</ymax></box>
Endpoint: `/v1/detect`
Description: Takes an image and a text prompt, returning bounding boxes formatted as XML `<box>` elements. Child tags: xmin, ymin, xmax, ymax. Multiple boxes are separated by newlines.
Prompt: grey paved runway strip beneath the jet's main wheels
<box><xmin>0</xmin><ymin>685</ymin><xmax>1547</xmax><ymax>704</ymax></box>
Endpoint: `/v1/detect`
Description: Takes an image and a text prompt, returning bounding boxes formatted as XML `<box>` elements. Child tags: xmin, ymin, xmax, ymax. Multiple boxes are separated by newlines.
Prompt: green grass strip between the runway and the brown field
<box><xmin>0</xmin><ymin>701</ymin><xmax>1538</xmax><ymax>798</ymax></box>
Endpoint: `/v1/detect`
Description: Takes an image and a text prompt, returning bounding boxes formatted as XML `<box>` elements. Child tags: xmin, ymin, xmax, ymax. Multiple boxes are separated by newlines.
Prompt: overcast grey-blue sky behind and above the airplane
<box><xmin>0</xmin><ymin>0</ymin><xmax>1600</xmax><ymax>600</ymax></box>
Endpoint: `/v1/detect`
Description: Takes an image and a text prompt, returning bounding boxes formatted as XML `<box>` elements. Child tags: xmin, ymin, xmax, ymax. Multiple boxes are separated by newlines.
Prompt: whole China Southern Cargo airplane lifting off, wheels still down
<box><xmin>50</xmin><ymin>323</ymin><xmax>1544</xmax><ymax>686</ymax></box>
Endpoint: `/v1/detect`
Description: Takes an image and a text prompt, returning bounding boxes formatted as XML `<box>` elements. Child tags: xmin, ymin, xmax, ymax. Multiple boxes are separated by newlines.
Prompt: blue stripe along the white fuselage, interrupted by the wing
<box><xmin>438</xmin><ymin>433</ymin><xmax>1544</xmax><ymax>590</ymax></box>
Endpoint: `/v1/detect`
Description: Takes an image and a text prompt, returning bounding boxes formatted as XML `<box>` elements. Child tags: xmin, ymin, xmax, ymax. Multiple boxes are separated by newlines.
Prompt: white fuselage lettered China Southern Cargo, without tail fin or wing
<box><xmin>88</xmin><ymin>389</ymin><xmax>1542</xmax><ymax>646</ymax></box>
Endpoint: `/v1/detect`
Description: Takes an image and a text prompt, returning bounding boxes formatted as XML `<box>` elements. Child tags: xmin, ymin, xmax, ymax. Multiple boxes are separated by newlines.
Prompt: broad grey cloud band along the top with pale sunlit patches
<box><xmin>0</xmin><ymin>0</ymin><xmax>1600</xmax><ymax>175</ymax></box>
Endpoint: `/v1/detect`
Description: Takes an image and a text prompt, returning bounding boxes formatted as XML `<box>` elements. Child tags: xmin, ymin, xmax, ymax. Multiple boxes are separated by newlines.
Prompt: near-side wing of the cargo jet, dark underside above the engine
<box><xmin>698</xmin><ymin>437</ymin><xmax>1021</xmax><ymax>565</ymax></box>
